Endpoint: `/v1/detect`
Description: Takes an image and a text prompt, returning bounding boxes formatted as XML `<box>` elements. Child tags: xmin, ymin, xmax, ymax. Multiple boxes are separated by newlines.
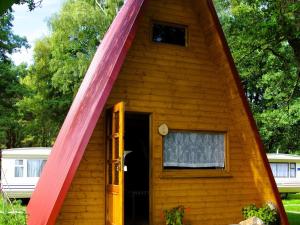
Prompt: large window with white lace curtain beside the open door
<box><xmin>163</xmin><ymin>132</ymin><xmax>225</xmax><ymax>169</ymax></box>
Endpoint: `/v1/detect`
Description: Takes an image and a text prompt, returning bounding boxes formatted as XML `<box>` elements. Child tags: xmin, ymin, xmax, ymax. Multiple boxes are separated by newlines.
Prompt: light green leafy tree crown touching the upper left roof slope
<box><xmin>47</xmin><ymin>0</ymin><xmax>109</xmax><ymax>95</ymax></box>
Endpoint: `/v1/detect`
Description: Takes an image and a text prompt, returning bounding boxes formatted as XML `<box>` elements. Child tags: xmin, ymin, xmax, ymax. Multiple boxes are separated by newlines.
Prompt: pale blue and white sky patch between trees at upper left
<box><xmin>11</xmin><ymin>0</ymin><xmax>64</xmax><ymax>65</ymax></box>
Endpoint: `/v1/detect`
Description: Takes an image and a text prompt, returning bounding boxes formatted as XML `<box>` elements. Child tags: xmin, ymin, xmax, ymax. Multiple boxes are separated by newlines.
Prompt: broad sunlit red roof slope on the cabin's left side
<box><xmin>27</xmin><ymin>0</ymin><xmax>145</xmax><ymax>225</ymax></box>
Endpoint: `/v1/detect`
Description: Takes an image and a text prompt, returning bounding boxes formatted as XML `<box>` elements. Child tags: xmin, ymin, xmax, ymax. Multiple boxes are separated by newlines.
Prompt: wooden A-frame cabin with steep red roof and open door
<box><xmin>28</xmin><ymin>0</ymin><xmax>288</xmax><ymax>225</ymax></box>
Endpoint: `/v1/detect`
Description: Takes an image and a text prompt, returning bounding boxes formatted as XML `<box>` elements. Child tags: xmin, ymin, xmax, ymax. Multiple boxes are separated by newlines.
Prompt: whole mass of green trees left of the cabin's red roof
<box><xmin>0</xmin><ymin>0</ymin><xmax>122</xmax><ymax>148</ymax></box>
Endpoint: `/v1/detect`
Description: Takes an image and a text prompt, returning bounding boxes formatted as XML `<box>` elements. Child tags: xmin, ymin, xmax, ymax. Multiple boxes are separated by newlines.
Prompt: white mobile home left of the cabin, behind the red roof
<box><xmin>1</xmin><ymin>147</ymin><xmax>51</xmax><ymax>198</ymax></box>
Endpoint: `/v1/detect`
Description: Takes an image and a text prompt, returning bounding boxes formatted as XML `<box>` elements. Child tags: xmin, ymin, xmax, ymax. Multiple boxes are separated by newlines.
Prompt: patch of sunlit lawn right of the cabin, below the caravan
<box><xmin>282</xmin><ymin>193</ymin><xmax>300</xmax><ymax>225</ymax></box>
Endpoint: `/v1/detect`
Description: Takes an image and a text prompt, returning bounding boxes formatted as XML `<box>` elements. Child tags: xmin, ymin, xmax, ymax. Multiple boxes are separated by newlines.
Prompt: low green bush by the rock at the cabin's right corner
<box><xmin>242</xmin><ymin>204</ymin><xmax>280</xmax><ymax>225</ymax></box>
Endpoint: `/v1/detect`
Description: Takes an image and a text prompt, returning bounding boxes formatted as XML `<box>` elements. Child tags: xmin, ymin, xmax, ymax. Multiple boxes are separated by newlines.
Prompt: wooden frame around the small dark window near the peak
<box><xmin>150</xmin><ymin>20</ymin><xmax>189</xmax><ymax>48</ymax></box>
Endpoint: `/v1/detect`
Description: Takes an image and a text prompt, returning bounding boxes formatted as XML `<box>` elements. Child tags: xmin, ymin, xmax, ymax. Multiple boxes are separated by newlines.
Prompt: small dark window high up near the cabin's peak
<box><xmin>152</xmin><ymin>22</ymin><xmax>187</xmax><ymax>46</ymax></box>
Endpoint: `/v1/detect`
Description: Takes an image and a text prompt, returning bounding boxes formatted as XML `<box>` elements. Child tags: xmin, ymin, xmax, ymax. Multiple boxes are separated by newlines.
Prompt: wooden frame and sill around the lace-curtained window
<box><xmin>160</xmin><ymin>129</ymin><xmax>232</xmax><ymax>179</ymax></box>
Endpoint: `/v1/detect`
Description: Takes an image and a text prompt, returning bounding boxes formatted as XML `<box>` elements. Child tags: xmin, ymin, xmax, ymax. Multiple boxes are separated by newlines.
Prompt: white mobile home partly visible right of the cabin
<box><xmin>267</xmin><ymin>153</ymin><xmax>300</xmax><ymax>193</ymax></box>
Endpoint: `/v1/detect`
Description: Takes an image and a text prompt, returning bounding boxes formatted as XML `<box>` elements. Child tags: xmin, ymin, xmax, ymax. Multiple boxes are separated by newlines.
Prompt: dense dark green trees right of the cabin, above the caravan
<box><xmin>215</xmin><ymin>0</ymin><xmax>300</xmax><ymax>152</ymax></box>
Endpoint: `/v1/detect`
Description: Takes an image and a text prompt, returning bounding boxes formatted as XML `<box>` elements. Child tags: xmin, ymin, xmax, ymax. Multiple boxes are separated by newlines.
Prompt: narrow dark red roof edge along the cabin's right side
<box><xmin>207</xmin><ymin>0</ymin><xmax>289</xmax><ymax>225</ymax></box>
